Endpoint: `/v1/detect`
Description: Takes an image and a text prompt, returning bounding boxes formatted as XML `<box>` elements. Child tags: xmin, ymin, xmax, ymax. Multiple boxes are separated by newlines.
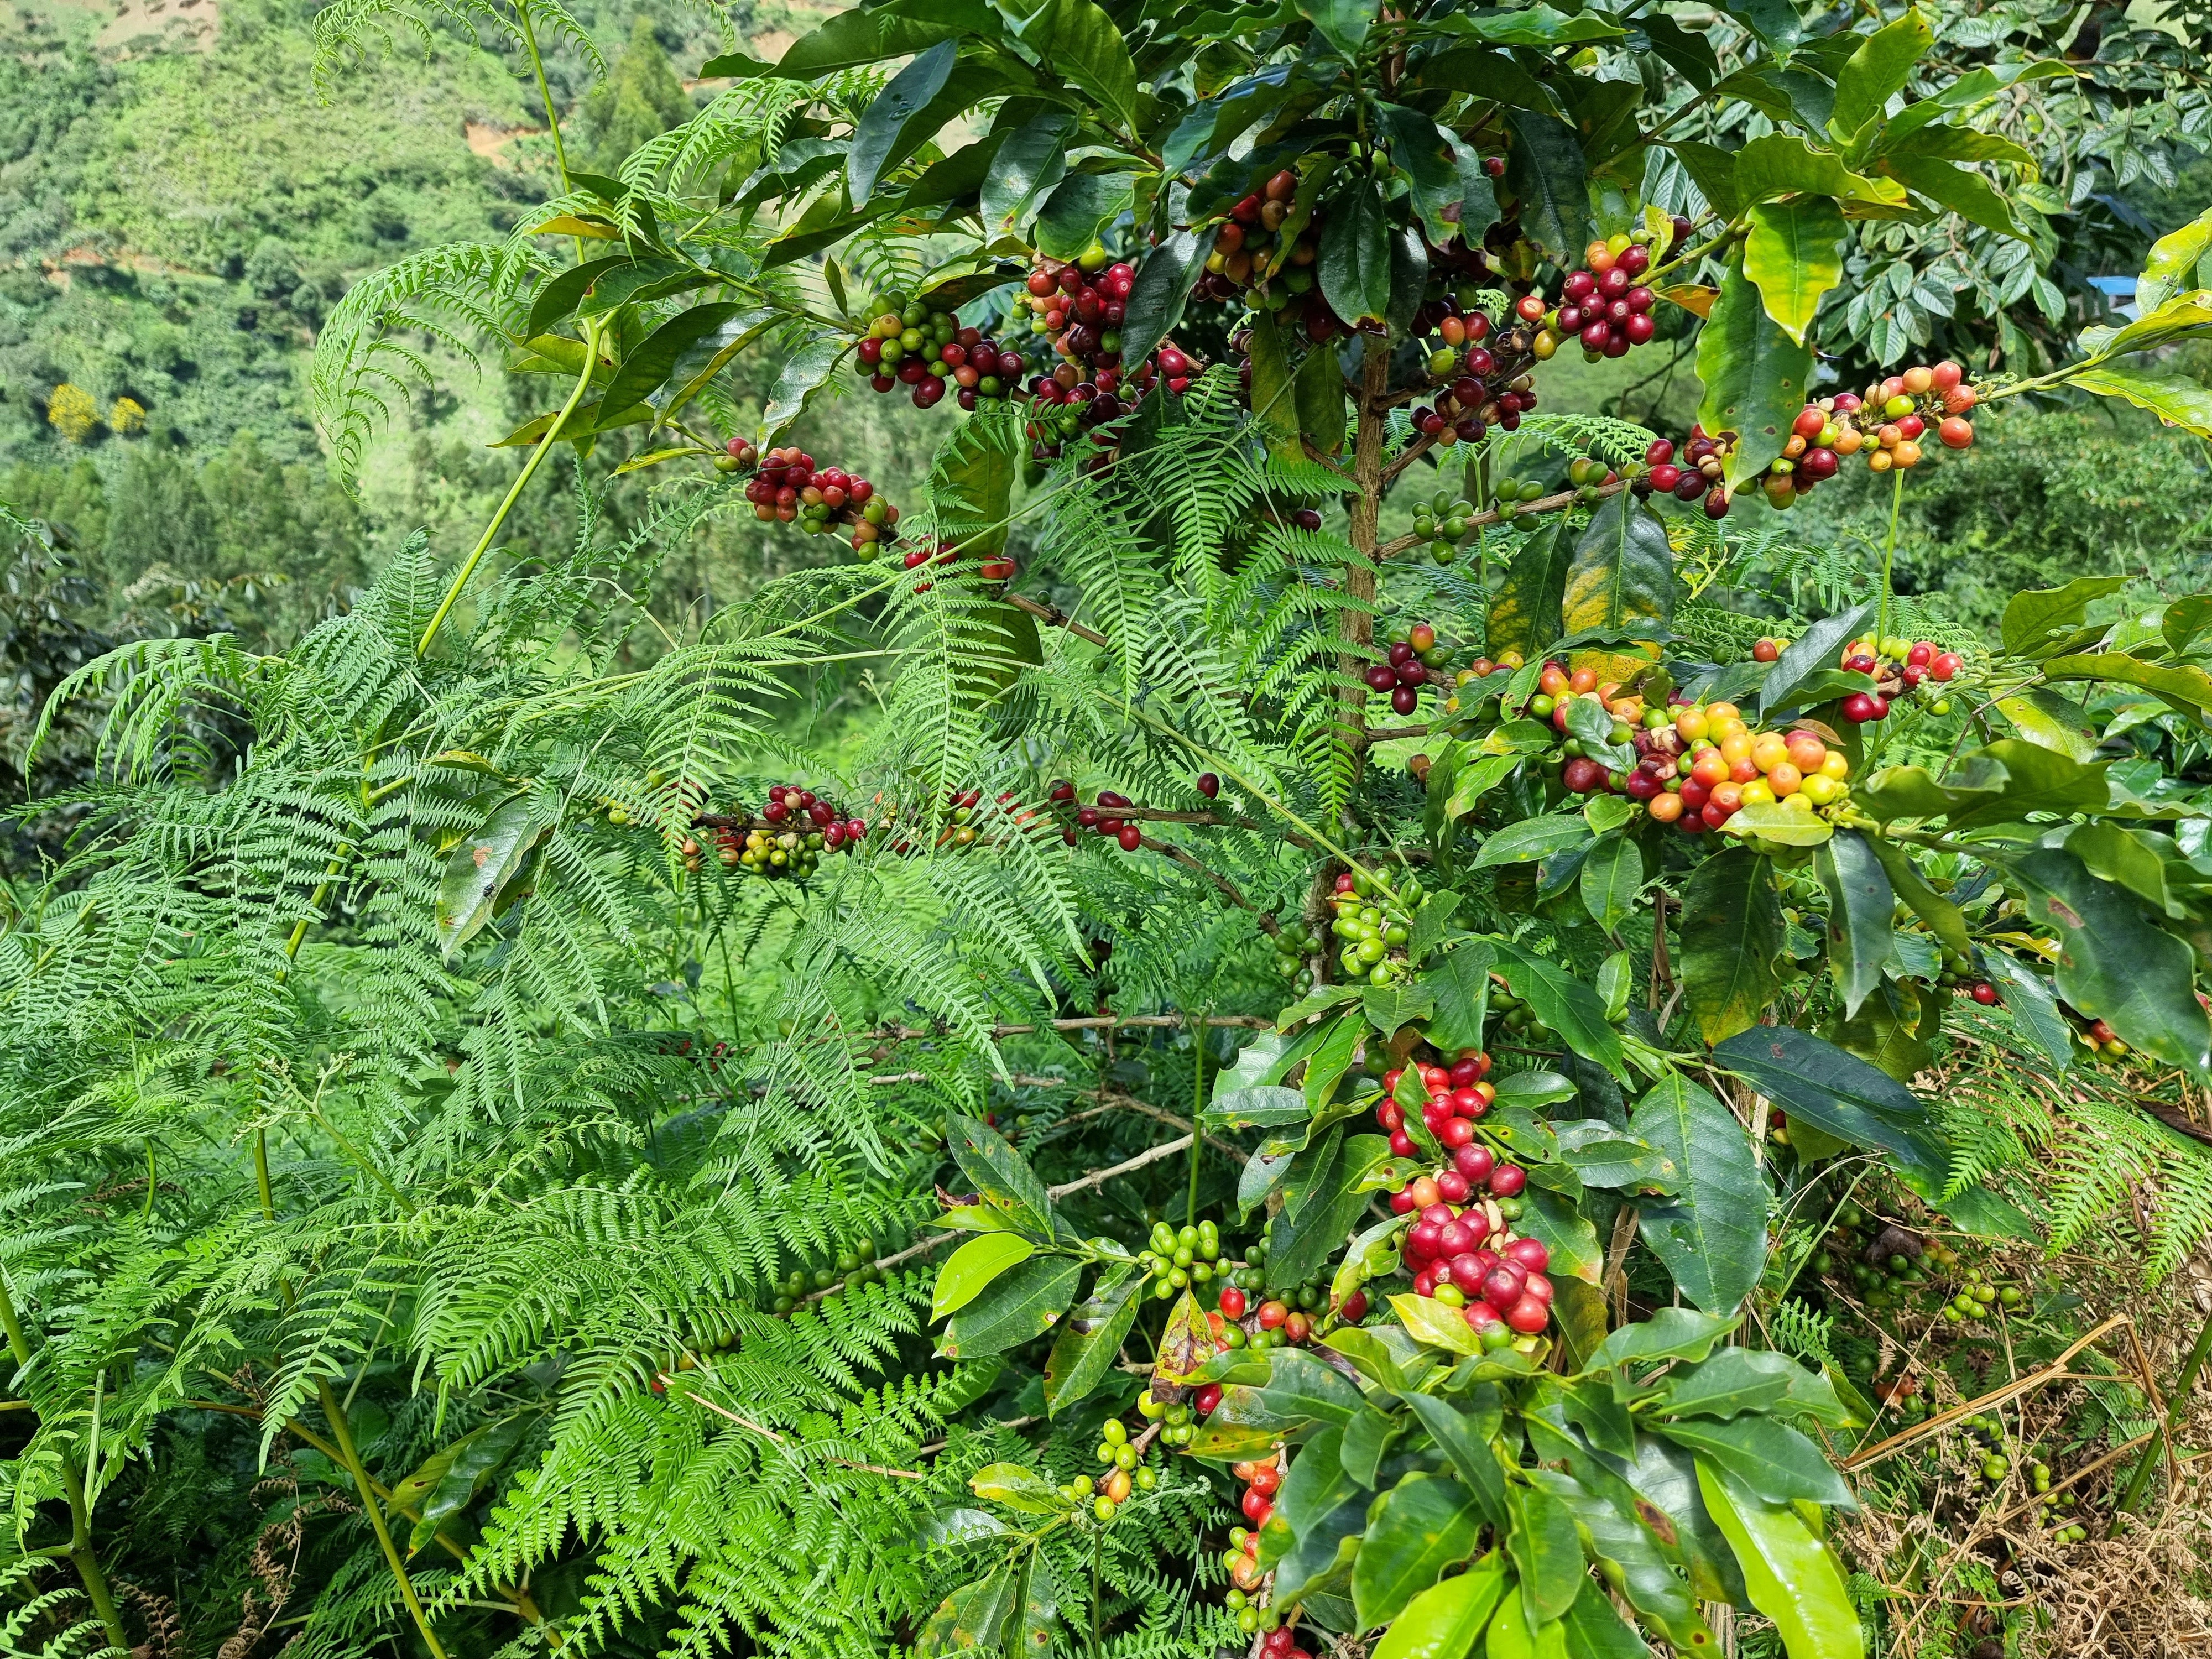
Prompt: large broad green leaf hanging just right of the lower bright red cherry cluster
<box><xmin>1628</xmin><ymin>1073</ymin><xmax>1770</xmax><ymax>1314</ymax></box>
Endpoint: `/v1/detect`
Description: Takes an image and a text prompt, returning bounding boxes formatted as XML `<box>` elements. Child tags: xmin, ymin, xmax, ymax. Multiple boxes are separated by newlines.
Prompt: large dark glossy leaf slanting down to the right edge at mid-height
<box><xmin>2011</xmin><ymin>847</ymin><xmax>2212</xmax><ymax>1079</ymax></box>
